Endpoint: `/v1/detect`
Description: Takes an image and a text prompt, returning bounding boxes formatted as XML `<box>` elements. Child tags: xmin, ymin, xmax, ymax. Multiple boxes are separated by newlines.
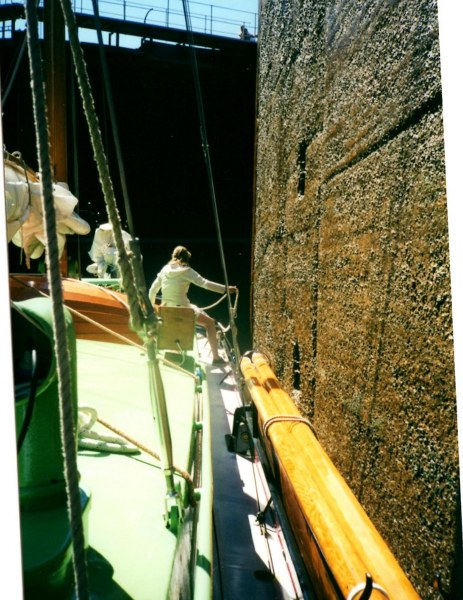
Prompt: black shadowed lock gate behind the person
<box><xmin>0</xmin><ymin>33</ymin><xmax>256</xmax><ymax>351</ymax></box>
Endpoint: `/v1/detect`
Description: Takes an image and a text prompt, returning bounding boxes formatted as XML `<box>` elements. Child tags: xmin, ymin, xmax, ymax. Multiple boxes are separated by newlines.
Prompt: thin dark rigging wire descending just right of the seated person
<box><xmin>182</xmin><ymin>0</ymin><xmax>241</xmax><ymax>370</ymax></box>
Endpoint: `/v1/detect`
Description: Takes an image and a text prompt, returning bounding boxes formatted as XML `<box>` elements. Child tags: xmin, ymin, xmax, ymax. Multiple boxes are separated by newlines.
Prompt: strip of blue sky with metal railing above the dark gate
<box><xmin>0</xmin><ymin>0</ymin><xmax>258</xmax><ymax>47</ymax></box>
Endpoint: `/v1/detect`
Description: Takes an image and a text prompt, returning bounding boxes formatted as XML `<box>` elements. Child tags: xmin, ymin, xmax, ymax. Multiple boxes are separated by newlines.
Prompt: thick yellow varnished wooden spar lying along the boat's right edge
<box><xmin>240</xmin><ymin>353</ymin><xmax>419</xmax><ymax>600</ymax></box>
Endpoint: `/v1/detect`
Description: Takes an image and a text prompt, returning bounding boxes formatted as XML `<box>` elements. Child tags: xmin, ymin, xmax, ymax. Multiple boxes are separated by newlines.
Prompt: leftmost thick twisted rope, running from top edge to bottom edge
<box><xmin>25</xmin><ymin>0</ymin><xmax>89</xmax><ymax>600</ymax></box>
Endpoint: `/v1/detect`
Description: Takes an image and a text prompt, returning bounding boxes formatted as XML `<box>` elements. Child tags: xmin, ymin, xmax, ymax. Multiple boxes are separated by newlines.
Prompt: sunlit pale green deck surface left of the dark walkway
<box><xmin>78</xmin><ymin>341</ymin><xmax>212</xmax><ymax>600</ymax></box>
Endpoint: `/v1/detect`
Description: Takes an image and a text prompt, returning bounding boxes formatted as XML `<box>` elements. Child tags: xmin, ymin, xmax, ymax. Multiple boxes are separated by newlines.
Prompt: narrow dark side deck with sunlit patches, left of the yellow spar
<box><xmin>200</xmin><ymin>341</ymin><xmax>309</xmax><ymax>600</ymax></box>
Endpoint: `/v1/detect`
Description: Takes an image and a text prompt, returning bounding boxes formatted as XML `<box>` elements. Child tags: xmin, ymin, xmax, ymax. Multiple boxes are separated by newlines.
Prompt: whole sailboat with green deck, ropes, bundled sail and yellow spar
<box><xmin>5</xmin><ymin>0</ymin><xmax>424</xmax><ymax>600</ymax></box>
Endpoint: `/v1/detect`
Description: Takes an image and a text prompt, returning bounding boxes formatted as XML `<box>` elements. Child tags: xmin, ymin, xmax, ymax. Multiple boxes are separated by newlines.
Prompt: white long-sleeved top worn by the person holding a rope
<box><xmin>149</xmin><ymin>263</ymin><xmax>226</xmax><ymax>306</ymax></box>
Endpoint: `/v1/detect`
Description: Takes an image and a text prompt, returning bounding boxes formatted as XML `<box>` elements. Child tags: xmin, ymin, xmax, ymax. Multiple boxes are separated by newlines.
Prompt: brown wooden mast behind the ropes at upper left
<box><xmin>44</xmin><ymin>0</ymin><xmax>68</xmax><ymax>276</ymax></box>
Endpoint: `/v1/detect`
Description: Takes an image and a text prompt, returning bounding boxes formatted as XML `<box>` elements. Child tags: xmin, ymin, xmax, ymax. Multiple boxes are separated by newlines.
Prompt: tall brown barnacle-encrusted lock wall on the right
<box><xmin>253</xmin><ymin>0</ymin><xmax>463</xmax><ymax>598</ymax></box>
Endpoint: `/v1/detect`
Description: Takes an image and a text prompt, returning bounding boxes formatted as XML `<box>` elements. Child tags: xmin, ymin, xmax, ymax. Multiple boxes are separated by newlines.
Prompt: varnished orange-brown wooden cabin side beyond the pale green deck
<box><xmin>10</xmin><ymin>274</ymin><xmax>141</xmax><ymax>344</ymax></box>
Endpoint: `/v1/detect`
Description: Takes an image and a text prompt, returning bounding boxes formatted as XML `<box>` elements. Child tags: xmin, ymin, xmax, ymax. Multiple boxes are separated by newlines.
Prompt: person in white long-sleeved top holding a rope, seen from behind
<box><xmin>149</xmin><ymin>246</ymin><xmax>238</xmax><ymax>365</ymax></box>
